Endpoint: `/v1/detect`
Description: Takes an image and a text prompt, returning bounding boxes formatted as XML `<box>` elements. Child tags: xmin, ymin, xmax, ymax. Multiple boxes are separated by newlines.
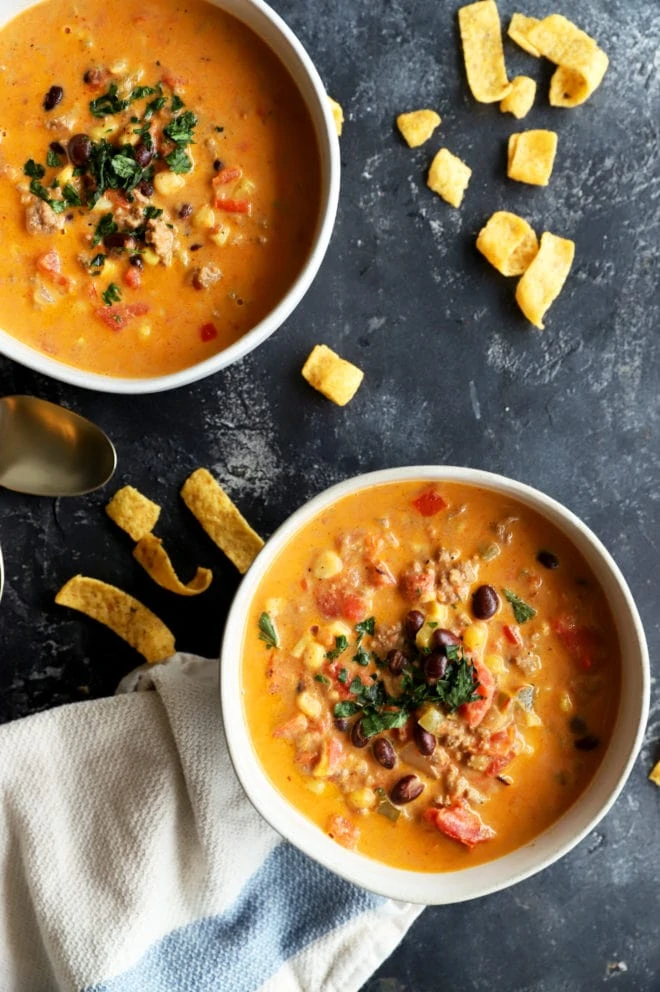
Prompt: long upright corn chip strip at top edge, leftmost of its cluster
<box><xmin>458</xmin><ymin>0</ymin><xmax>511</xmax><ymax>103</ymax></box>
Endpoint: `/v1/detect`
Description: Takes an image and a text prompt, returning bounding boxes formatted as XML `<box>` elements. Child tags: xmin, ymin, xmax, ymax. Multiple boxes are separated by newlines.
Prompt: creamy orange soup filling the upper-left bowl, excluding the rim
<box><xmin>0</xmin><ymin>0</ymin><xmax>320</xmax><ymax>376</ymax></box>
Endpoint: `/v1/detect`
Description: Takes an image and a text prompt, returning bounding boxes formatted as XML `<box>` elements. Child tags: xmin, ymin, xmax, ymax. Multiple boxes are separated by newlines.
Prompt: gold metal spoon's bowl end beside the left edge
<box><xmin>0</xmin><ymin>396</ymin><xmax>117</xmax><ymax>496</ymax></box>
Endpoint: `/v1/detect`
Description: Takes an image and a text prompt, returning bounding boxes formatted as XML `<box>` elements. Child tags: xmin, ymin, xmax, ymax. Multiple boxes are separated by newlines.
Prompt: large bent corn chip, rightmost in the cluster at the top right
<box><xmin>526</xmin><ymin>14</ymin><xmax>609</xmax><ymax>107</ymax></box>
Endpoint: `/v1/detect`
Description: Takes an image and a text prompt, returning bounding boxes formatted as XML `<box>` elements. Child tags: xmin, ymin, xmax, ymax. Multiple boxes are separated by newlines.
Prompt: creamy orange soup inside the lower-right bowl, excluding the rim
<box><xmin>243</xmin><ymin>482</ymin><xmax>620</xmax><ymax>871</ymax></box>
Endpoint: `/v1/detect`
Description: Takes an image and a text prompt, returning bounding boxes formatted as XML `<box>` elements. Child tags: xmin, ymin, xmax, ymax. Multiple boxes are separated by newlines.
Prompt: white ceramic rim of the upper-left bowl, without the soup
<box><xmin>0</xmin><ymin>0</ymin><xmax>340</xmax><ymax>393</ymax></box>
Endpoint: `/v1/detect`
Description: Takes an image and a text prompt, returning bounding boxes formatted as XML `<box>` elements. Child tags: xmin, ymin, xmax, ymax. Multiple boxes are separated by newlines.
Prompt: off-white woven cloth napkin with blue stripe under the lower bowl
<box><xmin>0</xmin><ymin>655</ymin><xmax>421</xmax><ymax>992</ymax></box>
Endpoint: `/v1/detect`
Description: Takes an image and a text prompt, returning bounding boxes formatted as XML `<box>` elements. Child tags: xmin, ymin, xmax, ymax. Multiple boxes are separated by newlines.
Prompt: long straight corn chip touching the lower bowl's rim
<box><xmin>181</xmin><ymin>468</ymin><xmax>264</xmax><ymax>573</ymax></box>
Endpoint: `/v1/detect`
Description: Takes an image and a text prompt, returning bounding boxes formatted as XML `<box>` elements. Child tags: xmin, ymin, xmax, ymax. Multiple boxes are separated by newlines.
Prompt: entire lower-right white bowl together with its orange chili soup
<box><xmin>221</xmin><ymin>466</ymin><xmax>649</xmax><ymax>903</ymax></box>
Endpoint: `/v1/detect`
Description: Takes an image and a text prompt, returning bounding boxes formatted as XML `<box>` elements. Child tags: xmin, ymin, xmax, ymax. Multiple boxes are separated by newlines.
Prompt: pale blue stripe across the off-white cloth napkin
<box><xmin>87</xmin><ymin>843</ymin><xmax>385</xmax><ymax>992</ymax></box>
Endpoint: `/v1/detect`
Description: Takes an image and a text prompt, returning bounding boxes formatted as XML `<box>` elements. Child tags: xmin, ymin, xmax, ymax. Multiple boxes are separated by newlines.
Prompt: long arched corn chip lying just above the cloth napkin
<box><xmin>55</xmin><ymin>575</ymin><xmax>176</xmax><ymax>665</ymax></box>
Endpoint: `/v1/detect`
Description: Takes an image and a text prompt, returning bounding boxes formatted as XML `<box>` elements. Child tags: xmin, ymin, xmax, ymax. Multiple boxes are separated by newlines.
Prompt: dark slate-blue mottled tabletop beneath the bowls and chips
<box><xmin>0</xmin><ymin>0</ymin><xmax>660</xmax><ymax>992</ymax></box>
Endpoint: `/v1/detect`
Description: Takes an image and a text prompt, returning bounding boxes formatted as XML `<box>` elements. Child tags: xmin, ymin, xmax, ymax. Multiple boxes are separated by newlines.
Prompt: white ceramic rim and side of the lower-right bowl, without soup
<box><xmin>220</xmin><ymin>466</ymin><xmax>649</xmax><ymax>904</ymax></box>
